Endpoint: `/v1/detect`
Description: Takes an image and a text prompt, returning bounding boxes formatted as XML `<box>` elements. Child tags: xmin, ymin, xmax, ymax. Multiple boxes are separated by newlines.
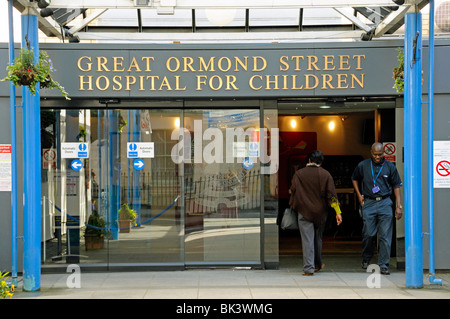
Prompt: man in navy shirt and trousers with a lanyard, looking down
<box><xmin>352</xmin><ymin>143</ymin><xmax>402</xmax><ymax>275</ymax></box>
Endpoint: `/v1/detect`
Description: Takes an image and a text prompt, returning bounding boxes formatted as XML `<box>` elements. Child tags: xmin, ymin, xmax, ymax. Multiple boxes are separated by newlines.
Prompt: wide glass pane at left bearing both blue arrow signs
<box><xmin>41</xmin><ymin>109</ymin><xmax>184</xmax><ymax>267</ymax></box>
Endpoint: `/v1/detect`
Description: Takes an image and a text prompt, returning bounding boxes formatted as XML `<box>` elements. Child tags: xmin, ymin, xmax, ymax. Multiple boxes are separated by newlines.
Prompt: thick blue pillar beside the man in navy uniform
<box><xmin>404</xmin><ymin>12</ymin><xmax>423</xmax><ymax>288</ymax></box>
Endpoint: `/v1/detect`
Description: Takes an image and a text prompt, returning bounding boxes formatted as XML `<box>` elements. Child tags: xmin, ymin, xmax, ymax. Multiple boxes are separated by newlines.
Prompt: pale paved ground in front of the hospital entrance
<box><xmin>7</xmin><ymin>256</ymin><xmax>450</xmax><ymax>302</ymax></box>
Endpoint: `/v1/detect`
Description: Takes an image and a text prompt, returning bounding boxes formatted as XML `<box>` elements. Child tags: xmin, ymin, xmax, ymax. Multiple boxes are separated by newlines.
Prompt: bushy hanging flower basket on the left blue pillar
<box><xmin>1</xmin><ymin>48</ymin><xmax>70</xmax><ymax>100</ymax></box>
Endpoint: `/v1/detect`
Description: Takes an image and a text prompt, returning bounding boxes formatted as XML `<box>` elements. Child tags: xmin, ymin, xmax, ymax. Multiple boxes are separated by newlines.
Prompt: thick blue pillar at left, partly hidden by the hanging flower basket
<box><xmin>22</xmin><ymin>11</ymin><xmax>41</xmax><ymax>291</ymax></box>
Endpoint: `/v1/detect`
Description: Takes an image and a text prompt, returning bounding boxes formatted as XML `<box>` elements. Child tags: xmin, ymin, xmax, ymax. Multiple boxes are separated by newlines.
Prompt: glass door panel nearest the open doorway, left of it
<box><xmin>183</xmin><ymin>109</ymin><xmax>261</xmax><ymax>266</ymax></box>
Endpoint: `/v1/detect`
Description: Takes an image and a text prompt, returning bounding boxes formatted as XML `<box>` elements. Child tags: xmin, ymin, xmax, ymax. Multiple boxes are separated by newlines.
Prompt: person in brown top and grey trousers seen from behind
<box><xmin>290</xmin><ymin>150</ymin><xmax>342</xmax><ymax>276</ymax></box>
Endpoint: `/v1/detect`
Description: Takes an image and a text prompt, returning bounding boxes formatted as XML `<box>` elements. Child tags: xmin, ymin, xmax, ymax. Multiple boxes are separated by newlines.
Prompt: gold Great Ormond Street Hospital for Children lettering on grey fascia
<box><xmin>77</xmin><ymin>54</ymin><xmax>366</xmax><ymax>92</ymax></box>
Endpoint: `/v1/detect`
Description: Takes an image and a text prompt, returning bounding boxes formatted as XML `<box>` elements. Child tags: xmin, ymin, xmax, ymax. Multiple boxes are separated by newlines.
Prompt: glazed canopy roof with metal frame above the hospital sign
<box><xmin>14</xmin><ymin>0</ymin><xmax>428</xmax><ymax>43</ymax></box>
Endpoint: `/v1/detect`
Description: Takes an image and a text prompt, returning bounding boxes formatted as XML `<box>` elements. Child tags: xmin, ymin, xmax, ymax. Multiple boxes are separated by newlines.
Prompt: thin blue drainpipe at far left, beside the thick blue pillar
<box><xmin>8</xmin><ymin>0</ymin><xmax>17</xmax><ymax>286</ymax></box>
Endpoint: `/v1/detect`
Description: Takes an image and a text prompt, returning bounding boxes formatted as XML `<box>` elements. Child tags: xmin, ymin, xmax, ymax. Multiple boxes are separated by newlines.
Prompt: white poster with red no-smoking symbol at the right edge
<box><xmin>433</xmin><ymin>141</ymin><xmax>450</xmax><ymax>188</ymax></box>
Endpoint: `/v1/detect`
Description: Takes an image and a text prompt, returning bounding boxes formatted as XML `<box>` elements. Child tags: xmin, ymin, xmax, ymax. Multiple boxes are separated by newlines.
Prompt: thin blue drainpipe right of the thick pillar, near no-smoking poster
<box><xmin>428</xmin><ymin>0</ymin><xmax>442</xmax><ymax>285</ymax></box>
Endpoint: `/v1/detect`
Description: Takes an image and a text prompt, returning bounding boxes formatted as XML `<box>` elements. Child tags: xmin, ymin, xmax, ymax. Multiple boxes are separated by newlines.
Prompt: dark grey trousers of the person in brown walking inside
<box><xmin>298</xmin><ymin>214</ymin><xmax>325</xmax><ymax>274</ymax></box>
